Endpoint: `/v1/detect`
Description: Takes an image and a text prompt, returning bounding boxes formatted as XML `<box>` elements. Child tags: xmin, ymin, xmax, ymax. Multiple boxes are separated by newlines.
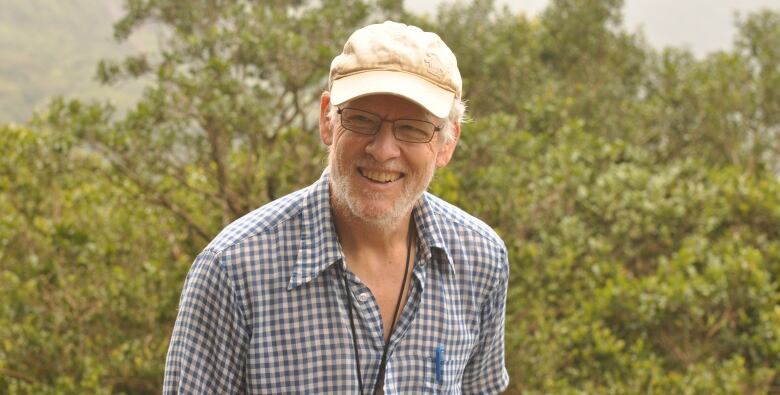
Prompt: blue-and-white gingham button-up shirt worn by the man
<box><xmin>163</xmin><ymin>170</ymin><xmax>508</xmax><ymax>394</ymax></box>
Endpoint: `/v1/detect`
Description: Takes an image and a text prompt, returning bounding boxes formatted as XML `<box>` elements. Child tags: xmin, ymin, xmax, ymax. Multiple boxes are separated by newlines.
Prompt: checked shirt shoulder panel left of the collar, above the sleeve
<box><xmin>204</xmin><ymin>186</ymin><xmax>311</xmax><ymax>255</ymax></box>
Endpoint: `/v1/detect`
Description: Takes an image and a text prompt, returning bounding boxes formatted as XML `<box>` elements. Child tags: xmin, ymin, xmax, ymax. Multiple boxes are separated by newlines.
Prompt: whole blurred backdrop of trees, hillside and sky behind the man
<box><xmin>0</xmin><ymin>0</ymin><xmax>780</xmax><ymax>394</ymax></box>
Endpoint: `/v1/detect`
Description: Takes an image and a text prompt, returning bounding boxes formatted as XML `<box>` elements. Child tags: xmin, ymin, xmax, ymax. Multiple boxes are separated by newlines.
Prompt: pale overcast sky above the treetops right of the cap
<box><xmin>405</xmin><ymin>0</ymin><xmax>780</xmax><ymax>56</ymax></box>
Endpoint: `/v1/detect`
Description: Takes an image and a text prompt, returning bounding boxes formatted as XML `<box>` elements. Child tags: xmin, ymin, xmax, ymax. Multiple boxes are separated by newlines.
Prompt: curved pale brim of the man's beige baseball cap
<box><xmin>330</xmin><ymin>70</ymin><xmax>455</xmax><ymax>118</ymax></box>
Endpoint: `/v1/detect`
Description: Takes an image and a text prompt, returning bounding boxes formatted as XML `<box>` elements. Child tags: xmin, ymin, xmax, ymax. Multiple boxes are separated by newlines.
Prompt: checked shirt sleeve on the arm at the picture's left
<box><xmin>163</xmin><ymin>252</ymin><xmax>249</xmax><ymax>394</ymax></box>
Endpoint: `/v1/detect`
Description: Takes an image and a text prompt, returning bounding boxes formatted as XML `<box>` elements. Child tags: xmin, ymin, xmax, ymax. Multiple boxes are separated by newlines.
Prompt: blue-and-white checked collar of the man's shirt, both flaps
<box><xmin>287</xmin><ymin>168</ymin><xmax>454</xmax><ymax>290</ymax></box>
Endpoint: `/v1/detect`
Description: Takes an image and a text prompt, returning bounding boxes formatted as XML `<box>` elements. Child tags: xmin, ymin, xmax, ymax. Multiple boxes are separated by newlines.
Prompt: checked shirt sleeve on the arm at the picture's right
<box><xmin>462</xmin><ymin>249</ymin><xmax>509</xmax><ymax>394</ymax></box>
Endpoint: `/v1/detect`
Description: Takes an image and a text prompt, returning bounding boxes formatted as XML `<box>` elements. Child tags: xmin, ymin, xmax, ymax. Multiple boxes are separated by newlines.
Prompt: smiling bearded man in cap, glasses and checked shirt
<box><xmin>164</xmin><ymin>22</ymin><xmax>508</xmax><ymax>394</ymax></box>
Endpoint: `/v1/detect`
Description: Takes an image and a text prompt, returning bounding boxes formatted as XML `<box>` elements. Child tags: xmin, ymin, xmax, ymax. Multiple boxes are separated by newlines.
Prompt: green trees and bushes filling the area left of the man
<box><xmin>0</xmin><ymin>1</ymin><xmax>399</xmax><ymax>393</ymax></box>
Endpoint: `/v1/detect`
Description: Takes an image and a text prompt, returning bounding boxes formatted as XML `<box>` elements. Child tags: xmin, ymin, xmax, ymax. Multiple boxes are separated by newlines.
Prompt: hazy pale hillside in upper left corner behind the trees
<box><xmin>0</xmin><ymin>0</ymin><xmax>156</xmax><ymax>123</ymax></box>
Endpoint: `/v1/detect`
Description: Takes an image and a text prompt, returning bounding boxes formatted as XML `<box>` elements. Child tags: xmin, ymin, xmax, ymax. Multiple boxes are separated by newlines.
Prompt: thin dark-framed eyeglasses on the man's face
<box><xmin>338</xmin><ymin>108</ymin><xmax>441</xmax><ymax>143</ymax></box>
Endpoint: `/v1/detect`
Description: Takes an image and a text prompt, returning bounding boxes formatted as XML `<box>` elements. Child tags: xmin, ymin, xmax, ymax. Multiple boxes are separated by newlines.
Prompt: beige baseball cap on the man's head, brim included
<box><xmin>328</xmin><ymin>21</ymin><xmax>463</xmax><ymax>118</ymax></box>
